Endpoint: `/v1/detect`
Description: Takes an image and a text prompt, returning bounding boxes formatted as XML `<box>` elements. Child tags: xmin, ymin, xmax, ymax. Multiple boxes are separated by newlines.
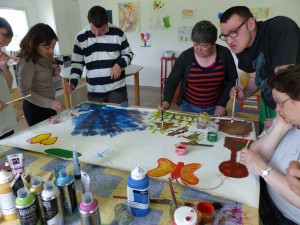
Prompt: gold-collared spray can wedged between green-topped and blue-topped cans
<box><xmin>29</xmin><ymin>176</ymin><xmax>46</xmax><ymax>224</ymax></box>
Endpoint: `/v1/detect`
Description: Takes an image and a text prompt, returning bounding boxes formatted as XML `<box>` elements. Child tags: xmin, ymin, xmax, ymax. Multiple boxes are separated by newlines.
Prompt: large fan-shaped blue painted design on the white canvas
<box><xmin>71</xmin><ymin>103</ymin><xmax>148</xmax><ymax>137</ymax></box>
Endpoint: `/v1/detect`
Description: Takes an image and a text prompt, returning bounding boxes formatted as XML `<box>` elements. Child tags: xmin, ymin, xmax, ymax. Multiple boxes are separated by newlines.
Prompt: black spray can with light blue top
<box><xmin>56</xmin><ymin>169</ymin><xmax>77</xmax><ymax>215</ymax></box>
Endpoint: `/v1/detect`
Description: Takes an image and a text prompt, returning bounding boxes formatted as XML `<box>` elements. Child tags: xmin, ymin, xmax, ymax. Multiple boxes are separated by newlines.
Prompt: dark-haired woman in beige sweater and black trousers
<box><xmin>17</xmin><ymin>23</ymin><xmax>64</xmax><ymax>126</ymax></box>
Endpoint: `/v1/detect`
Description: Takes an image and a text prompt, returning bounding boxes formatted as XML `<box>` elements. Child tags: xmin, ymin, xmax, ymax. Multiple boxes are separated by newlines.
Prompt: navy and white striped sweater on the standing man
<box><xmin>71</xmin><ymin>24</ymin><xmax>133</xmax><ymax>98</ymax></box>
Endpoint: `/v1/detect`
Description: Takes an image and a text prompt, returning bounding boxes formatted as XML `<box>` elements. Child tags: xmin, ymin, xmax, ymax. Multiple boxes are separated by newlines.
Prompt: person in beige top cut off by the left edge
<box><xmin>0</xmin><ymin>17</ymin><xmax>17</xmax><ymax>140</ymax></box>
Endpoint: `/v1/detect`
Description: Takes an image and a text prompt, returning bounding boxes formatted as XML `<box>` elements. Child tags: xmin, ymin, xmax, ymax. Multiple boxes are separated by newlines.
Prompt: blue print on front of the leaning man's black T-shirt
<box><xmin>253</xmin><ymin>52</ymin><xmax>273</xmax><ymax>101</ymax></box>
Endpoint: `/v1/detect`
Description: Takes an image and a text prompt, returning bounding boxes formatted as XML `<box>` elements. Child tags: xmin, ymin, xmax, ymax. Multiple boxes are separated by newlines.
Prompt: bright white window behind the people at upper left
<box><xmin>0</xmin><ymin>8</ymin><xmax>28</xmax><ymax>51</ymax></box>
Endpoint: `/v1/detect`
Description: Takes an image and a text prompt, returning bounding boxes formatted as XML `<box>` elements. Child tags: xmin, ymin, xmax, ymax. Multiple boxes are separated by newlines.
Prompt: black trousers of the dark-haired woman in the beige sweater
<box><xmin>23</xmin><ymin>100</ymin><xmax>57</xmax><ymax>127</ymax></box>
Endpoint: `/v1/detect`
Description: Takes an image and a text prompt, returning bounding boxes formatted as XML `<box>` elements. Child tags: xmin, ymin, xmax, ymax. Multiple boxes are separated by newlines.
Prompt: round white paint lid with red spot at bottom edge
<box><xmin>172</xmin><ymin>206</ymin><xmax>197</xmax><ymax>225</ymax></box>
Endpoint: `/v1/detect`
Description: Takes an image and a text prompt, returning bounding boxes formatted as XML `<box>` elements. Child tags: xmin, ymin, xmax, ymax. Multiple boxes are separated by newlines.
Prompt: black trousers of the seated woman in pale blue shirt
<box><xmin>259</xmin><ymin>178</ymin><xmax>297</xmax><ymax>225</ymax></box>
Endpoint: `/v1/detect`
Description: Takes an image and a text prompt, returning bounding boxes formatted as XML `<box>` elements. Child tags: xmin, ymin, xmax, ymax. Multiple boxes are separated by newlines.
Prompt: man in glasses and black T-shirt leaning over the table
<box><xmin>219</xmin><ymin>6</ymin><xmax>300</xmax><ymax>134</ymax></box>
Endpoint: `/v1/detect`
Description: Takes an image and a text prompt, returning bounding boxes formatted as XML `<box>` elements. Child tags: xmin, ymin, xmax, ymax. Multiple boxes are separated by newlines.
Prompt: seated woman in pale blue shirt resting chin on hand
<box><xmin>240</xmin><ymin>65</ymin><xmax>300</xmax><ymax>225</ymax></box>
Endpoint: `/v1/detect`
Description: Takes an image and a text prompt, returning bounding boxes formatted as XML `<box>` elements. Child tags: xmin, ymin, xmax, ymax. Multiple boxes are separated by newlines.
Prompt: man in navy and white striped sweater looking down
<box><xmin>67</xmin><ymin>6</ymin><xmax>133</xmax><ymax>104</ymax></box>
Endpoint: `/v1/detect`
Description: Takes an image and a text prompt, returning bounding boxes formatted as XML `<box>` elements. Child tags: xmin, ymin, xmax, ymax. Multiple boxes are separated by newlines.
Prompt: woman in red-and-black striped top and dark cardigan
<box><xmin>158</xmin><ymin>21</ymin><xmax>237</xmax><ymax>116</ymax></box>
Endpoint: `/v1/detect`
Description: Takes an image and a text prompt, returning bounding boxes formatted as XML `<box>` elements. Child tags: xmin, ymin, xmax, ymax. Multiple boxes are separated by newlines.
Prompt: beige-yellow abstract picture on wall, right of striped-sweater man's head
<box><xmin>118</xmin><ymin>2</ymin><xmax>138</xmax><ymax>32</ymax></box>
